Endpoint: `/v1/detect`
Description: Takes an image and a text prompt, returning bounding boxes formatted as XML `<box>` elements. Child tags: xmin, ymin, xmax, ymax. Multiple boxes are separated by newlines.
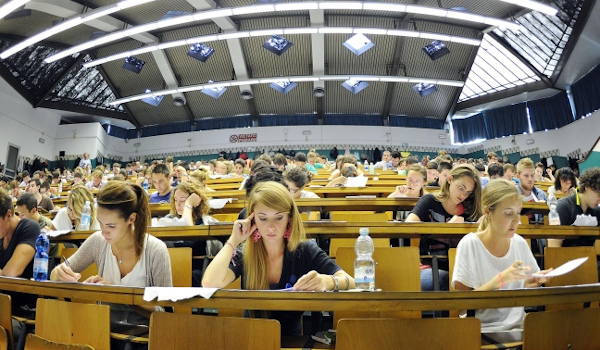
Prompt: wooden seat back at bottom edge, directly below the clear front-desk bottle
<box><xmin>335</xmin><ymin>318</ymin><xmax>481</xmax><ymax>350</ymax></box>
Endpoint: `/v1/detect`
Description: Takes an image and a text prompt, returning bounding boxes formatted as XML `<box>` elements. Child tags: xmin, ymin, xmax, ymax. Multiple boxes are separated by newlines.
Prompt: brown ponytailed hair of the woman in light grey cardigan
<box><xmin>97</xmin><ymin>181</ymin><xmax>150</xmax><ymax>259</ymax></box>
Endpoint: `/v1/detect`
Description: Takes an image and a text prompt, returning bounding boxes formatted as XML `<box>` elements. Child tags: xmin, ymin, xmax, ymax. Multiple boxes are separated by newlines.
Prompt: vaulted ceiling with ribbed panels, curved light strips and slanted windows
<box><xmin>0</xmin><ymin>0</ymin><xmax>595</xmax><ymax>128</ymax></box>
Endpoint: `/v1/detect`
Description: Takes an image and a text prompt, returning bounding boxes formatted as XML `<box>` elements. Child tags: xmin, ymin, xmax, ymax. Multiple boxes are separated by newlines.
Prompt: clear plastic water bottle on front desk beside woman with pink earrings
<box><xmin>354</xmin><ymin>227</ymin><xmax>375</xmax><ymax>291</ymax></box>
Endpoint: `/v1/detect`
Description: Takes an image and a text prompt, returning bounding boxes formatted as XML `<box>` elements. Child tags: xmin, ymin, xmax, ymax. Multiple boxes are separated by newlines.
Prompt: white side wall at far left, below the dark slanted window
<box><xmin>0</xmin><ymin>79</ymin><xmax>60</xmax><ymax>164</ymax></box>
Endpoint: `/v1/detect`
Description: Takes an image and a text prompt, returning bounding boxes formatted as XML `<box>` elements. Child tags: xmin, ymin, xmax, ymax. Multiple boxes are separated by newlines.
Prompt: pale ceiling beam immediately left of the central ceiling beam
<box><xmin>186</xmin><ymin>0</ymin><xmax>258</xmax><ymax>120</ymax></box>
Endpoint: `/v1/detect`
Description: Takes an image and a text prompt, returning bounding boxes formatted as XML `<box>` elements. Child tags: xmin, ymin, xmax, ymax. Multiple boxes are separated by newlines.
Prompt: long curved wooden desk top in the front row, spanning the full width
<box><xmin>0</xmin><ymin>277</ymin><xmax>600</xmax><ymax>311</ymax></box>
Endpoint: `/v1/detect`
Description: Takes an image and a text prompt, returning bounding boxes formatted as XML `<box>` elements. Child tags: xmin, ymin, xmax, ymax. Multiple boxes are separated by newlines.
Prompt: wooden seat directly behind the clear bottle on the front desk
<box><xmin>333</xmin><ymin>247</ymin><xmax>421</xmax><ymax>325</ymax></box>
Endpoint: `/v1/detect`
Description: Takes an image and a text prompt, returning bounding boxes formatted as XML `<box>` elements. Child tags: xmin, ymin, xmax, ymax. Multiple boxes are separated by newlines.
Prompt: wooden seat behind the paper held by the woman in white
<box><xmin>544</xmin><ymin>247</ymin><xmax>598</xmax><ymax>310</ymax></box>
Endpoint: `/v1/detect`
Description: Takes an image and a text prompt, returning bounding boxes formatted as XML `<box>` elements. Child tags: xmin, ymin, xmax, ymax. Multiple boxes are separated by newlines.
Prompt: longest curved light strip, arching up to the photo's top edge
<box><xmin>44</xmin><ymin>1</ymin><xmax>521</xmax><ymax>63</ymax></box>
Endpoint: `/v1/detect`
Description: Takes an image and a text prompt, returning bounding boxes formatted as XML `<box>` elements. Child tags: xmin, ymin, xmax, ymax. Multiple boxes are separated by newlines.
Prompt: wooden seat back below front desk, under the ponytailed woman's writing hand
<box><xmin>35</xmin><ymin>298</ymin><xmax>110</xmax><ymax>350</ymax></box>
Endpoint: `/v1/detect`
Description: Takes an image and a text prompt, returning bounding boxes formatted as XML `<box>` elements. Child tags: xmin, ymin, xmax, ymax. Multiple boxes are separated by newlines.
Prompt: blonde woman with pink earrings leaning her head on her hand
<box><xmin>202</xmin><ymin>182</ymin><xmax>354</xmax><ymax>335</ymax></box>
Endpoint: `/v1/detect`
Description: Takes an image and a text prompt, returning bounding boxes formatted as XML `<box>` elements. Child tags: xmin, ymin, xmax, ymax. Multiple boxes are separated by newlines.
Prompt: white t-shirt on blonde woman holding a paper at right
<box><xmin>452</xmin><ymin>233</ymin><xmax>540</xmax><ymax>333</ymax></box>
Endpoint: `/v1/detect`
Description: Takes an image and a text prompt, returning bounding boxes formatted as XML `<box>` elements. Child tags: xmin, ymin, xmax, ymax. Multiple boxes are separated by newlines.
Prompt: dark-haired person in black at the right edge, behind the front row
<box><xmin>548</xmin><ymin>167</ymin><xmax>600</xmax><ymax>247</ymax></box>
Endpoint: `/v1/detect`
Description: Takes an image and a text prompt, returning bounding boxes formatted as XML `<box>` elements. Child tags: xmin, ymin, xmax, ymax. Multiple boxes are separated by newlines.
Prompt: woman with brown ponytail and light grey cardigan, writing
<box><xmin>51</xmin><ymin>181</ymin><xmax>173</xmax><ymax>324</ymax></box>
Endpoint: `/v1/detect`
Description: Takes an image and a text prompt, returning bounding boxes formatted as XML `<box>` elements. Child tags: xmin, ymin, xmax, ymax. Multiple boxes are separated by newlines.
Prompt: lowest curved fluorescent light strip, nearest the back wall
<box><xmin>110</xmin><ymin>75</ymin><xmax>464</xmax><ymax>106</ymax></box>
